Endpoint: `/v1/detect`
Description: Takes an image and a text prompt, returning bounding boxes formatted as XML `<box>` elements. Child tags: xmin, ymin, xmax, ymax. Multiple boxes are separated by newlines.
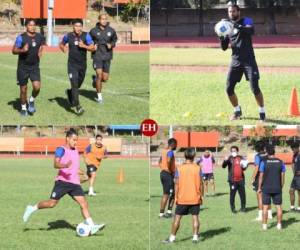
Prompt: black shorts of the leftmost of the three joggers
<box><xmin>17</xmin><ymin>65</ymin><xmax>41</xmax><ymax>86</ymax></box>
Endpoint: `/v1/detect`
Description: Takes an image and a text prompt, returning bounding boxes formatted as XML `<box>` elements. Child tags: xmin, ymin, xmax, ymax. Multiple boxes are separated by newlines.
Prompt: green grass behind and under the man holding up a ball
<box><xmin>150</xmin><ymin>48</ymin><xmax>300</xmax><ymax>125</ymax></box>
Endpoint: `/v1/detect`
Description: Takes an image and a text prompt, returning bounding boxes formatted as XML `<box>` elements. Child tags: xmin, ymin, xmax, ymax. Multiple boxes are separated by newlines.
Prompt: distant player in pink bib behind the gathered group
<box><xmin>197</xmin><ymin>150</ymin><xmax>215</xmax><ymax>196</ymax></box>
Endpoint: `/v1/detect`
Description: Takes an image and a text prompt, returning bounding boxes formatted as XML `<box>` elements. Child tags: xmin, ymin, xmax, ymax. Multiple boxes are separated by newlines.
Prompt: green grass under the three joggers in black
<box><xmin>0</xmin><ymin>52</ymin><xmax>149</xmax><ymax>125</ymax></box>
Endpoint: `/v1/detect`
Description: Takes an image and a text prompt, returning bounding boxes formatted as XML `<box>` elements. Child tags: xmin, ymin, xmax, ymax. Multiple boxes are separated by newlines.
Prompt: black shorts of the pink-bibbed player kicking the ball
<box><xmin>50</xmin><ymin>181</ymin><xmax>84</xmax><ymax>200</ymax></box>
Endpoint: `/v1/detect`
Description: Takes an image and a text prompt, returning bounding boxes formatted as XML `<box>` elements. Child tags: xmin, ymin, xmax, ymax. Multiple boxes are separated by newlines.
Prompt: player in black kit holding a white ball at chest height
<box><xmin>220</xmin><ymin>5</ymin><xmax>266</xmax><ymax>121</ymax></box>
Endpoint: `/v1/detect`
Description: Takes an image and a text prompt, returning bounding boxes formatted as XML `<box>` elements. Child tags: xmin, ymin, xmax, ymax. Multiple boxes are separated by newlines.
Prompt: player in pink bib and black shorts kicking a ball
<box><xmin>23</xmin><ymin>129</ymin><xmax>105</xmax><ymax>234</ymax></box>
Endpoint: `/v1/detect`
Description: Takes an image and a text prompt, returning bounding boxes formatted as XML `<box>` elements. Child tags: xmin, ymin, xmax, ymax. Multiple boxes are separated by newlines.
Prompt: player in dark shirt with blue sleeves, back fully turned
<box><xmin>258</xmin><ymin>145</ymin><xmax>286</xmax><ymax>230</ymax></box>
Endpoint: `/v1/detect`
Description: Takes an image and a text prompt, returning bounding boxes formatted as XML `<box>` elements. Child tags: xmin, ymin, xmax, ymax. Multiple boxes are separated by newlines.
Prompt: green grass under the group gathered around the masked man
<box><xmin>150</xmin><ymin>165</ymin><xmax>300</xmax><ymax>250</ymax></box>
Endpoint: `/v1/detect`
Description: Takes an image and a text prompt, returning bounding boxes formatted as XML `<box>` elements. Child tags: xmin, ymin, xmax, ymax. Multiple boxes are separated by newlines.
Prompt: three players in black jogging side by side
<box><xmin>12</xmin><ymin>14</ymin><xmax>117</xmax><ymax>116</ymax></box>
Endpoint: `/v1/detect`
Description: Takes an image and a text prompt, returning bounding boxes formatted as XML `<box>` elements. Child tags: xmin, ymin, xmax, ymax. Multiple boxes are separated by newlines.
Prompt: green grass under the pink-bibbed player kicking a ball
<box><xmin>0</xmin><ymin>159</ymin><xmax>149</xmax><ymax>249</ymax></box>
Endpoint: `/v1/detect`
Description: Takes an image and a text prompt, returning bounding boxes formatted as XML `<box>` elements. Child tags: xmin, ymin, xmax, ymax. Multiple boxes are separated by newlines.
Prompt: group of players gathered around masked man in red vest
<box><xmin>159</xmin><ymin>138</ymin><xmax>300</xmax><ymax>243</ymax></box>
